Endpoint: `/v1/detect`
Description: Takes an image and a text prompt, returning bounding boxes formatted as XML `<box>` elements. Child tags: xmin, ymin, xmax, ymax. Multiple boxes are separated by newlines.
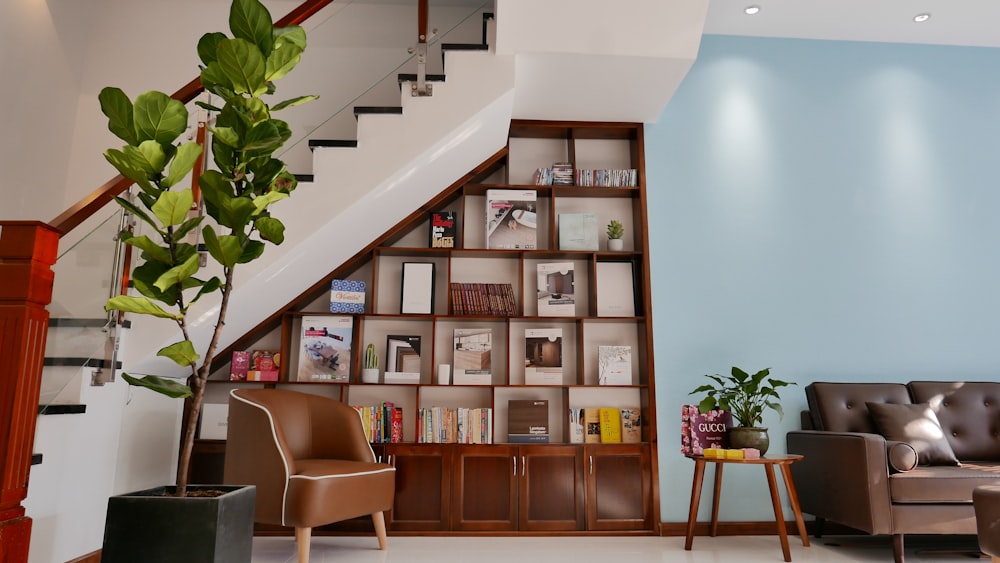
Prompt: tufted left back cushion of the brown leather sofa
<box><xmin>806</xmin><ymin>382</ymin><xmax>912</xmax><ymax>433</ymax></box>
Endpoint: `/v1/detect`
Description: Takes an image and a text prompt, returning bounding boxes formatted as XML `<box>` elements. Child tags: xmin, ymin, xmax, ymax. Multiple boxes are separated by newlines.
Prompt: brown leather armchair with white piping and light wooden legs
<box><xmin>225</xmin><ymin>389</ymin><xmax>395</xmax><ymax>563</ymax></box>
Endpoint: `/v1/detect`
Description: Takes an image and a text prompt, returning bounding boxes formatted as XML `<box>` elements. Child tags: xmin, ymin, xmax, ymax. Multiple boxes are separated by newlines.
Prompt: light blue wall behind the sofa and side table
<box><xmin>646</xmin><ymin>36</ymin><xmax>1000</xmax><ymax>522</ymax></box>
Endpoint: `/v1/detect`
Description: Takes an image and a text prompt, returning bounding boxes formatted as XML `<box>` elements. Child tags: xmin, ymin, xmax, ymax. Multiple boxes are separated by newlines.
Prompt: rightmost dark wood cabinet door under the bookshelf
<box><xmin>585</xmin><ymin>444</ymin><xmax>653</xmax><ymax>530</ymax></box>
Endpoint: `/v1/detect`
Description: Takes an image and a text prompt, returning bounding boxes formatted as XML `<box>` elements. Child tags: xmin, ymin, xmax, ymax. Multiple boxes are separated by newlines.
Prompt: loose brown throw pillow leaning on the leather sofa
<box><xmin>867</xmin><ymin>403</ymin><xmax>958</xmax><ymax>465</ymax></box>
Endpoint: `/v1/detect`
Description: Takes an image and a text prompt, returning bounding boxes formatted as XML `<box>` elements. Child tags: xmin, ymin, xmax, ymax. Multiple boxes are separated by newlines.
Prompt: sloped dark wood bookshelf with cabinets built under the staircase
<box><xmin>199</xmin><ymin>121</ymin><xmax>658</xmax><ymax>534</ymax></box>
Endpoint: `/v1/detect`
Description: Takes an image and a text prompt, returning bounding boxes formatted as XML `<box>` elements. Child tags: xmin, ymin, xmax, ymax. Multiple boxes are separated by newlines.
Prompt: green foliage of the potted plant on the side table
<box><xmin>689</xmin><ymin>366</ymin><xmax>795</xmax><ymax>428</ymax></box>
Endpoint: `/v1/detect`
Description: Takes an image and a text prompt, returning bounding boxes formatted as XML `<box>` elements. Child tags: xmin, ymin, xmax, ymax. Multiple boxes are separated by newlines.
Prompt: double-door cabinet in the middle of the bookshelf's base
<box><xmin>453</xmin><ymin>445</ymin><xmax>584</xmax><ymax>531</ymax></box>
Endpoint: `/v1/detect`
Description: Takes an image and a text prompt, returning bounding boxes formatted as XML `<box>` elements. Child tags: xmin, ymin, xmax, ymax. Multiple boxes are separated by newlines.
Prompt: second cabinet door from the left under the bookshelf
<box><xmin>452</xmin><ymin>445</ymin><xmax>521</xmax><ymax>531</ymax></box>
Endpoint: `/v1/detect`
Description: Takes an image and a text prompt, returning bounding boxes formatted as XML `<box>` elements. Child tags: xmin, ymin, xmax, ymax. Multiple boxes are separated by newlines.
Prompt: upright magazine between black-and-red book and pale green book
<box><xmin>486</xmin><ymin>190</ymin><xmax>538</xmax><ymax>250</ymax></box>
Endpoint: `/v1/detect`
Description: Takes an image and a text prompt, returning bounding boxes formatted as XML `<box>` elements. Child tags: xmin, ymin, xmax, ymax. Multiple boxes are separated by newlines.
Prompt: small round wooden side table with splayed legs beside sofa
<box><xmin>684</xmin><ymin>454</ymin><xmax>809</xmax><ymax>561</ymax></box>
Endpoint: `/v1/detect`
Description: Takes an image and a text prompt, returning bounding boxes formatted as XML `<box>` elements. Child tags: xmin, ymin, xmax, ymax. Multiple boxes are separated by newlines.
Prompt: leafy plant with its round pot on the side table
<box><xmin>690</xmin><ymin>366</ymin><xmax>795</xmax><ymax>455</ymax></box>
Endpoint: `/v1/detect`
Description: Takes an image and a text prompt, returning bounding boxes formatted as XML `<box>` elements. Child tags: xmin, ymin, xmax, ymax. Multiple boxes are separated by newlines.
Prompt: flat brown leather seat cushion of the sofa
<box><xmin>889</xmin><ymin>462</ymin><xmax>1000</xmax><ymax>504</ymax></box>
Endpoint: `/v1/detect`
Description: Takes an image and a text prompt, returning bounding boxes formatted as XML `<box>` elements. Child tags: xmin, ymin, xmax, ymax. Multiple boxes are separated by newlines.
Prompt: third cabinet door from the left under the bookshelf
<box><xmin>518</xmin><ymin>446</ymin><xmax>584</xmax><ymax>531</ymax></box>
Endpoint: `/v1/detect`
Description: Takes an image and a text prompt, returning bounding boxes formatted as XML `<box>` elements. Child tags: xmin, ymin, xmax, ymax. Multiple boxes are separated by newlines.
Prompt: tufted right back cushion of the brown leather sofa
<box><xmin>909</xmin><ymin>381</ymin><xmax>1000</xmax><ymax>461</ymax></box>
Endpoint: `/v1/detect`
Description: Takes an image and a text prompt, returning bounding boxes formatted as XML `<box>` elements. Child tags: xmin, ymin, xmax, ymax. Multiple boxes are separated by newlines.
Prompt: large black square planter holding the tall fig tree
<box><xmin>101</xmin><ymin>485</ymin><xmax>257</xmax><ymax>563</ymax></box>
